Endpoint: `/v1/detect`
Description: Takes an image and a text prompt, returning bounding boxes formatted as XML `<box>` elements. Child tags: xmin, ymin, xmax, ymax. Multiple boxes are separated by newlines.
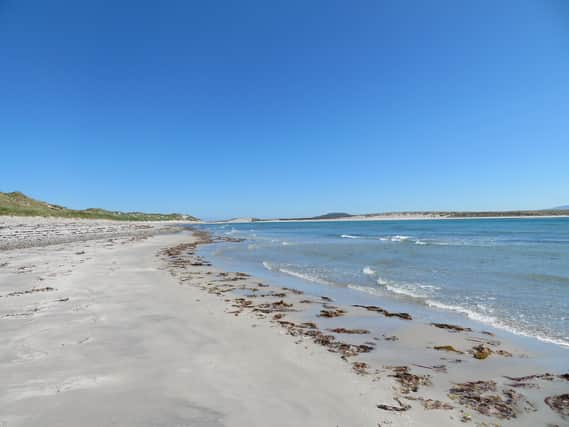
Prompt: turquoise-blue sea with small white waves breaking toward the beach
<box><xmin>195</xmin><ymin>218</ymin><xmax>569</xmax><ymax>346</ymax></box>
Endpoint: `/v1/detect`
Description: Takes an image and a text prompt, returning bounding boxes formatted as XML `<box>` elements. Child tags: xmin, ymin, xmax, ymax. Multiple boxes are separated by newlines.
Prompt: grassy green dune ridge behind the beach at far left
<box><xmin>0</xmin><ymin>191</ymin><xmax>197</xmax><ymax>221</ymax></box>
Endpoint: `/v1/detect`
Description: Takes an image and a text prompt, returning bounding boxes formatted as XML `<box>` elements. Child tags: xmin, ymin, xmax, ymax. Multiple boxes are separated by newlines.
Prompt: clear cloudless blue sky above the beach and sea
<box><xmin>0</xmin><ymin>0</ymin><xmax>569</xmax><ymax>218</ymax></box>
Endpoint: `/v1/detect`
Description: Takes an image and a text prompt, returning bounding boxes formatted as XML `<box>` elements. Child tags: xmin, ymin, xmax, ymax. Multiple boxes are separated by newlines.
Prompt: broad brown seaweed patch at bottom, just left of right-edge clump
<box><xmin>448</xmin><ymin>381</ymin><xmax>536</xmax><ymax>419</ymax></box>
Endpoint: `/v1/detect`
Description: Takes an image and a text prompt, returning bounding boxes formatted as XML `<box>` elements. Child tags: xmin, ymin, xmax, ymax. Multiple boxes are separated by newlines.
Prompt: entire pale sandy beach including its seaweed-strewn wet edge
<box><xmin>0</xmin><ymin>218</ymin><xmax>569</xmax><ymax>426</ymax></box>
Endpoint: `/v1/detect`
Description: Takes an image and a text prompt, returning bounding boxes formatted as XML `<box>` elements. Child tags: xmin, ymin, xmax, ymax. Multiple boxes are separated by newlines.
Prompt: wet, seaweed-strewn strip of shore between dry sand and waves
<box><xmin>185</xmin><ymin>232</ymin><xmax>569</xmax><ymax>425</ymax></box>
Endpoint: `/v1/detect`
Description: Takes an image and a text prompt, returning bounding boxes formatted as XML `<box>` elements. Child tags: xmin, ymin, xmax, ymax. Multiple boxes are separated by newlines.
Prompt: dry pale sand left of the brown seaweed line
<box><xmin>0</xmin><ymin>227</ymin><xmax>405</xmax><ymax>427</ymax></box>
